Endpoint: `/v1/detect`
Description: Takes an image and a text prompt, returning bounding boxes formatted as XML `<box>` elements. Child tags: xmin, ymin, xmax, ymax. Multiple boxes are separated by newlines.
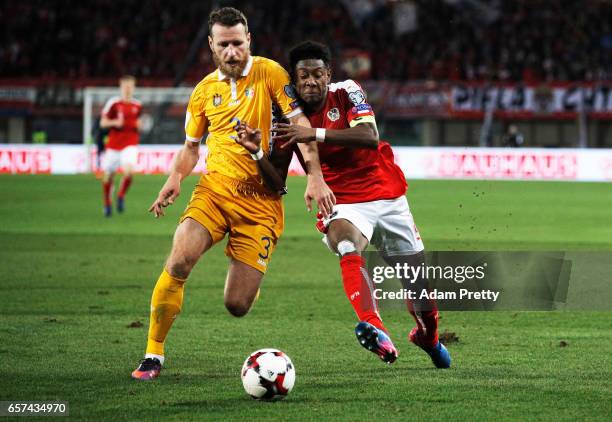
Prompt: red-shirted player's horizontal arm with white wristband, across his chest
<box><xmin>274</xmin><ymin>122</ymin><xmax>379</xmax><ymax>149</ymax></box>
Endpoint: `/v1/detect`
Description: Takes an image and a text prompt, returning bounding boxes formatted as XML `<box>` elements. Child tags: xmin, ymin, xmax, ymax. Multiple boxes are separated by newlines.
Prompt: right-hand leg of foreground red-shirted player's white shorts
<box><xmin>372</xmin><ymin>197</ymin><xmax>425</xmax><ymax>256</ymax></box>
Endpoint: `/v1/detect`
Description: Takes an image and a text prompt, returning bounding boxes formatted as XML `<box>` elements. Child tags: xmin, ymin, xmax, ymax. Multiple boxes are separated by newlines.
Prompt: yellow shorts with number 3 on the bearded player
<box><xmin>180</xmin><ymin>173</ymin><xmax>284</xmax><ymax>273</ymax></box>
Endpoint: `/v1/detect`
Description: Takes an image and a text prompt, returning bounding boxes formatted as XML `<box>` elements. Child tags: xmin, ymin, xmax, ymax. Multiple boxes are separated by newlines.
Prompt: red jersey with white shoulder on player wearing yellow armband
<box><xmin>307</xmin><ymin>79</ymin><xmax>407</xmax><ymax>204</ymax></box>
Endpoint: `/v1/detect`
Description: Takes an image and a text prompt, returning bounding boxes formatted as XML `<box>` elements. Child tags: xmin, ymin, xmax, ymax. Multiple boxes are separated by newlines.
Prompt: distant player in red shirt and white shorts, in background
<box><xmin>100</xmin><ymin>75</ymin><xmax>142</xmax><ymax>217</ymax></box>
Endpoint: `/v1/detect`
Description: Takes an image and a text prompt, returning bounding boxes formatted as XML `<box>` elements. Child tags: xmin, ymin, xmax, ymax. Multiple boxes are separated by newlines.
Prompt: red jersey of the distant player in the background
<box><xmin>102</xmin><ymin>97</ymin><xmax>142</xmax><ymax>150</ymax></box>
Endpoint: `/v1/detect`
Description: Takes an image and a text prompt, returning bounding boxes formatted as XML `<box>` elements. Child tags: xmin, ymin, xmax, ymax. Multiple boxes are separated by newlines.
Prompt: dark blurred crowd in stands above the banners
<box><xmin>0</xmin><ymin>0</ymin><xmax>612</xmax><ymax>83</ymax></box>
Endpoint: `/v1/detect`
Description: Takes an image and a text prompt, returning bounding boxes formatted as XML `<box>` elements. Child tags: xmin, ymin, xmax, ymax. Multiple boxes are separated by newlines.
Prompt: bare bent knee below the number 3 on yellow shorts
<box><xmin>223</xmin><ymin>258</ymin><xmax>264</xmax><ymax>316</ymax></box>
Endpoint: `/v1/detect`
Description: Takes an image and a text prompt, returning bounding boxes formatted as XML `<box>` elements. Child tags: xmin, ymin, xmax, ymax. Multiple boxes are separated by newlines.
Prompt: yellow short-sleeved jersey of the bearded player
<box><xmin>185</xmin><ymin>56</ymin><xmax>302</xmax><ymax>184</ymax></box>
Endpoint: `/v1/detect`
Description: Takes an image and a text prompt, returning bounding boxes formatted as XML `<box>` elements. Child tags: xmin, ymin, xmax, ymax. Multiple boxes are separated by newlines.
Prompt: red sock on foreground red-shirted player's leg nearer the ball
<box><xmin>340</xmin><ymin>255</ymin><xmax>387</xmax><ymax>332</ymax></box>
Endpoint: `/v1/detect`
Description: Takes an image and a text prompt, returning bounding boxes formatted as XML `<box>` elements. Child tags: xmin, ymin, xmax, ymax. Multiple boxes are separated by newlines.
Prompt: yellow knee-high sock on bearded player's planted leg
<box><xmin>146</xmin><ymin>269</ymin><xmax>186</xmax><ymax>356</ymax></box>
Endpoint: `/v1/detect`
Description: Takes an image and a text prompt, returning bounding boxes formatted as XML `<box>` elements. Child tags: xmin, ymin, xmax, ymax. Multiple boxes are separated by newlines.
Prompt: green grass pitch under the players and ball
<box><xmin>0</xmin><ymin>176</ymin><xmax>612</xmax><ymax>421</ymax></box>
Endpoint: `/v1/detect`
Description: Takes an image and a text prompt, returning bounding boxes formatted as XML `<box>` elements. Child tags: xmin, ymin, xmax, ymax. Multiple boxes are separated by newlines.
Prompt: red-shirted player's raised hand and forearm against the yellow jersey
<box><xmin>236</xmin><ymin>122</ymin><xmax>292</xmax><ymax>195</ymax></box>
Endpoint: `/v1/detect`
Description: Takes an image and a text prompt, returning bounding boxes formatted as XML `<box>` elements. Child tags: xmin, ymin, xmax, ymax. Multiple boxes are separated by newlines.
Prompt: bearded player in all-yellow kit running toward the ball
<box><xmin>132</xmin><ymin>7</ymin><xmax>335</xmax><ymax>380</ymax></box>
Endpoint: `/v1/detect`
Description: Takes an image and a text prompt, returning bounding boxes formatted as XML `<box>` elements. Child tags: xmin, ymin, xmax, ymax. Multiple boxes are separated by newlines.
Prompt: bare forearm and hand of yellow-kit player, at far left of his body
<box><xmin>149</xmin><ymin>141</ymin><xmax>200</xmax><ymax>218</ymax></box>
